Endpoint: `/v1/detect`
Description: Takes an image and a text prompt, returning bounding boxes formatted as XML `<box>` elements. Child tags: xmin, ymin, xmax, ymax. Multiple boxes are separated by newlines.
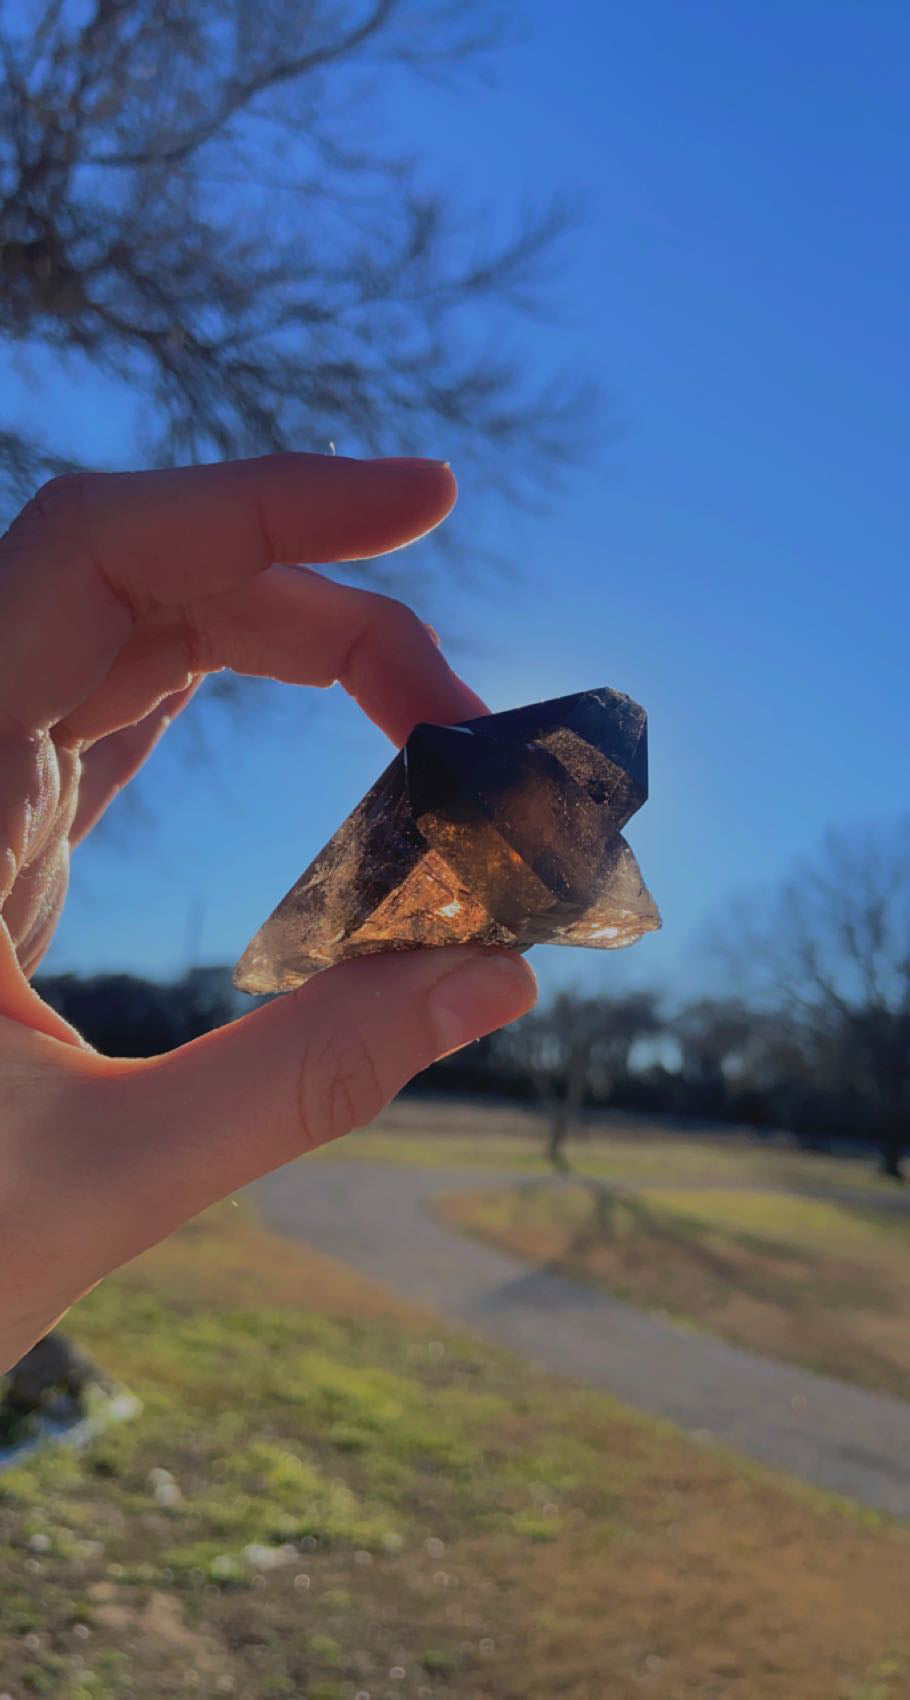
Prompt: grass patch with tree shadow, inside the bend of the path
<box><xmin>439</xmin><ymin>1180</ymin><xmax>910</xmax><ymax>1399</ymax></box>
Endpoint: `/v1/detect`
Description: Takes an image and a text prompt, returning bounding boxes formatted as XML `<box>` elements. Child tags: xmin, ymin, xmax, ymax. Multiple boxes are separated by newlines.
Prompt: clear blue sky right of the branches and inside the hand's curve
<box><xmin>22</xmin><ymin>0</ymin><xmax>910</xmax><ymax>989</ymax></box>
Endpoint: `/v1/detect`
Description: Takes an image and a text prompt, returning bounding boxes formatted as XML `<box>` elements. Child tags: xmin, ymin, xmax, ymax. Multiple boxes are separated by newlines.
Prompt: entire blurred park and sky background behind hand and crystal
<box><xmin>0</xmin><ymin>0</ymin><xmax>910</xmax><ymax>1700</ymax></box>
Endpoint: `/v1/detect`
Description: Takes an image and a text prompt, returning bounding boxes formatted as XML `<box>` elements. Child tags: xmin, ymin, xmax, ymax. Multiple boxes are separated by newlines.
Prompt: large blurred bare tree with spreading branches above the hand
<box><xmin>0</xmin><ymin>0</ymin><xmax>585</xmax><ymax>530</ymax></box>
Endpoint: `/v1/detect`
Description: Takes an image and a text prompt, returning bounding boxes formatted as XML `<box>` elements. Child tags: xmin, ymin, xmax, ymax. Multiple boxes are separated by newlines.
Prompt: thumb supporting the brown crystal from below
<box><xmin>92</xmin><ymin>945</ymin><xmax>536</xmax><ymax>1267</ymax></box>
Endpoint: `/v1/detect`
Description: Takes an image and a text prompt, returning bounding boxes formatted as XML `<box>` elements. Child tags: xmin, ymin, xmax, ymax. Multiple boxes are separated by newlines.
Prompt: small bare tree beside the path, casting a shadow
<box><xmin>502</xmin><ymin>991</ymin><xmax>662</xmax><ymax>1173</ymax></box>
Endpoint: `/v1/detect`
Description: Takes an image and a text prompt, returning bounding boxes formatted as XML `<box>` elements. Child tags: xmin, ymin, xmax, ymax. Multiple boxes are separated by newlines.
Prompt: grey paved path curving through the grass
<box><xmin>253</xmin><ymin>1159</ymin><xmax>910</xmax><ymax>1518</ymax></box>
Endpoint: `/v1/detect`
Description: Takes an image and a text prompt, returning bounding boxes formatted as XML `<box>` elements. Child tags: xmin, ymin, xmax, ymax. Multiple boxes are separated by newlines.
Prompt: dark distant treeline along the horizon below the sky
<box><xmin>37</xmin><ymin>967</ymin><xmax>903</xmax><ymax>1173</ymax></box>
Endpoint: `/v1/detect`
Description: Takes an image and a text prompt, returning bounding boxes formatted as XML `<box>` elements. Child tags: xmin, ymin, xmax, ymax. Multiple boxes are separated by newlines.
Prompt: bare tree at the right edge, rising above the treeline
<box><xmin>717</xmin><ymin>818</ymin><xmax>910</xmax><ymax>1180</ymax></box>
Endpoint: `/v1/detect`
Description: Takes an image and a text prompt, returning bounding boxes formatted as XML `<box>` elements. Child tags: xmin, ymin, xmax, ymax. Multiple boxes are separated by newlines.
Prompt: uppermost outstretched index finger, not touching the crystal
<box><xmin>0</xmin><ymin>454</ymin><xmax>456</xmax><ymax>733</ymax></box>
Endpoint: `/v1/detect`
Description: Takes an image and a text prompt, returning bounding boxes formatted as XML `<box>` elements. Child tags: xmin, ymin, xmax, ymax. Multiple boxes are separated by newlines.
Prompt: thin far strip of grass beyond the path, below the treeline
<box><xmin>328</xmin><ymin>1097</ymin><xmax>895</xmax><ymax>1197</ymax></box>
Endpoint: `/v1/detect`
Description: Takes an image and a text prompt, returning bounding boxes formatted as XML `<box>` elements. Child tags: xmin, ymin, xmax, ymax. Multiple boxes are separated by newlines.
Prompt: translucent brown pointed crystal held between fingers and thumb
<box><xmin>235</xmin><ymin>689</ymin><xmax>660</xmax><ymax>993</ymax></box>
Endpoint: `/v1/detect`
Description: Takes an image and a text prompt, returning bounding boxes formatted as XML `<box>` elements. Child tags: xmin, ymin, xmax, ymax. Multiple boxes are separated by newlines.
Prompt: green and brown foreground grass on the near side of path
<box><xmin>0</xmin><ymin>1207</ymin><xmax>910</xmax><ymax>1700</ymax></box>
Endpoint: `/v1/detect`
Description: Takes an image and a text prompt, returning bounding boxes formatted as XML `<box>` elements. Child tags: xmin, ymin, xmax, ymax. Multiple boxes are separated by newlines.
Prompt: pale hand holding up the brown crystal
<box><xmin>0</xmin><ymin>454</ymin><xmax>534</xmax><ymax>1370</ymax></box>
